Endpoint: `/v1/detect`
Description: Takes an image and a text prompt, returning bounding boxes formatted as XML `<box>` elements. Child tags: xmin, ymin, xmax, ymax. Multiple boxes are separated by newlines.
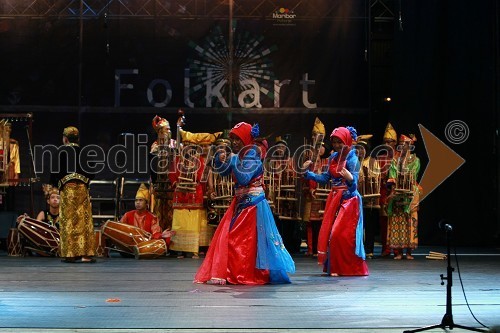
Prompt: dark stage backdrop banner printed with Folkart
<box><xmin>0</xmin><ymin>0</ymin><xmax>368</xmax><ymax>110</ymax></box>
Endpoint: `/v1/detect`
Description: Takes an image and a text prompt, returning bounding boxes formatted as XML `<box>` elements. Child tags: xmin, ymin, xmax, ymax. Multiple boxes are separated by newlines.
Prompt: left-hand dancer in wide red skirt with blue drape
<box><xmin>194</xmin><ymin>122</ymin><xmax>295</xmax><ymax>285</ymax></box>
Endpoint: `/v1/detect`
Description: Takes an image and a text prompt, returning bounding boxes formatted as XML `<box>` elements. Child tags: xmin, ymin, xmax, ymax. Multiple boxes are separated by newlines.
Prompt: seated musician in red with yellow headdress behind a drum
<box><xmin>103</xmin><ymin>184</ymin><xmax>174</xmax><ymax>258</ymax></box>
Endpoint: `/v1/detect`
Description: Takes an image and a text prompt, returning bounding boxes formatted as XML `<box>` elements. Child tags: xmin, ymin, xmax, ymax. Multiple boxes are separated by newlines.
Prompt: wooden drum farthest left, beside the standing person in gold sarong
<box><xmin>17</xmin><ymin>217</ymin><xmax>60</xmax><ymax>255</ymax></box>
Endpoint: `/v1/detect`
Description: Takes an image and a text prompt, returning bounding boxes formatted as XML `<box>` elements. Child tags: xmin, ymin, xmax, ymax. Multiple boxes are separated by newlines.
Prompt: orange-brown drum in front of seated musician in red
<box><xmin>101</xmin><ymin>220</ymin><xmax>151</xmax><ymax>253</ymax></box>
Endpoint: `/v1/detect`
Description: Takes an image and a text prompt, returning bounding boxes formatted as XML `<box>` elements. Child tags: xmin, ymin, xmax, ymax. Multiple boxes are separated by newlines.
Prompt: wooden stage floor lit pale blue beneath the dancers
<box><xmin>0</xmin><ymin>247</ymin><xmax>500</xmax><ymax>333</ymax></box>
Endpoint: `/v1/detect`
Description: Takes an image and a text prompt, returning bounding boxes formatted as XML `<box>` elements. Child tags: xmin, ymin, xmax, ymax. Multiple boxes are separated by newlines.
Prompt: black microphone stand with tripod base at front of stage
<box><xmin>403</xmin><ymin>225</ymin><xmax>488</xmax><ymax>333</ymax></box>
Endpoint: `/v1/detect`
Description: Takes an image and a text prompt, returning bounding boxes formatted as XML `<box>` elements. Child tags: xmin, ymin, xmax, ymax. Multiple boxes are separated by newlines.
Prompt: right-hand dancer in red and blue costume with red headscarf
<box><xmin>304</xmin><ymin>127</ymin><xmax>369</xmax><ymax>276</ymax></box>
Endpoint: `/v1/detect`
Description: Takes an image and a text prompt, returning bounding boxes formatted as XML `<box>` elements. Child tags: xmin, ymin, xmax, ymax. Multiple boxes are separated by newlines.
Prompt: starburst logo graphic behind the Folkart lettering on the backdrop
<box><xmin>187</xmin><ymin>24</ymin><xmax>277</xmax><ymax>107</ymax></box>
